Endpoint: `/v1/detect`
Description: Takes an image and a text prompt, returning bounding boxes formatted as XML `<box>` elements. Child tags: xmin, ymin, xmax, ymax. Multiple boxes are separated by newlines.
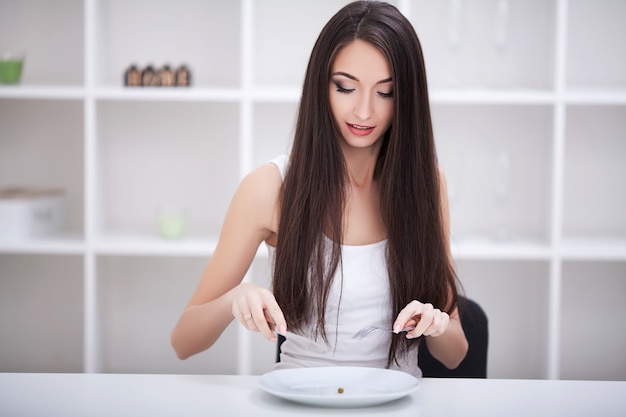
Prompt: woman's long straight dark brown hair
<box><xmin>273</xmin><ymin>1</ymin><xmax>458</xmax><ymax>364</ymax></box>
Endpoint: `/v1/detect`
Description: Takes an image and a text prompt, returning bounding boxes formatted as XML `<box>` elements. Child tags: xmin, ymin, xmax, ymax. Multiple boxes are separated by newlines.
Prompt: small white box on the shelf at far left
<box><xmin>0</xmin><ymin>187</ymin><xmax>65</xmax><ymax>240</ymax></box>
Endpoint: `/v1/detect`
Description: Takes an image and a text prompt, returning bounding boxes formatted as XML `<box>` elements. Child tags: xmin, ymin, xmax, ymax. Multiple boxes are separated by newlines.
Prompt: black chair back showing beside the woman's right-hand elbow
<box><xmin>417</xmin><ymin>297</ymin><xmax>489</xmax><ymax>378</ymax></box>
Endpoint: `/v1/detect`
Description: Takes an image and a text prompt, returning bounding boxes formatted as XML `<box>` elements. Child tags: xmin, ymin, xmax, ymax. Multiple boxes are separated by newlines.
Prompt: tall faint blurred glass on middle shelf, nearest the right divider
<box><xmin>493</xmin><ymin>151</ymin><xmax>513</xmax><ymax>241</ymax></box>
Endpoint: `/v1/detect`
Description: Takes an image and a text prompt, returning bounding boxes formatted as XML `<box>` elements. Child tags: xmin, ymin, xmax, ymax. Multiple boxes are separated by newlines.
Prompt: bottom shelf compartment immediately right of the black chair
<box><xmin>456</xmin><ymin>260</ymin><xmax>550</xmax><ymax>379</ymax></box>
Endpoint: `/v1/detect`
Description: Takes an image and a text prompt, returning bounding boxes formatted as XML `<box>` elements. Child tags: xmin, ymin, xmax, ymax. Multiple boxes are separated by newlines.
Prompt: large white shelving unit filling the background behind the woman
<box><xmin>0</xmin><ymin>0</ymin><xmax>626</xmax><ymax>379</ymax></box>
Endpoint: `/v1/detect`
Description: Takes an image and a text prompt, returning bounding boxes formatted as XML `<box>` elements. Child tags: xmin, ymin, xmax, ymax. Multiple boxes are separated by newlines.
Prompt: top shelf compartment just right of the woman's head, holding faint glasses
<box><xmin>409</xmin><ymin>0</ymin><xmax>556</xmax><ymax>90</ymax></box>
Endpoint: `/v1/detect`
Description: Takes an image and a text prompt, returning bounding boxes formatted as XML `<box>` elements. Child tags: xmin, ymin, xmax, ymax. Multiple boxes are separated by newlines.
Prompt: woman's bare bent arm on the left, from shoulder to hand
<box><xmin>171</xmin><ymin>164</ymin><xmax>286</xmax><ymax>359</ymax></box>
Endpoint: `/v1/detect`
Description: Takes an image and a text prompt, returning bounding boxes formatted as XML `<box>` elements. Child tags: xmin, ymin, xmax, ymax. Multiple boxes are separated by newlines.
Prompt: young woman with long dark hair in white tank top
<box><xmin>172</xmin><ymin>1</ymin><xmax>467</xmax><ymax>376</ymax></box>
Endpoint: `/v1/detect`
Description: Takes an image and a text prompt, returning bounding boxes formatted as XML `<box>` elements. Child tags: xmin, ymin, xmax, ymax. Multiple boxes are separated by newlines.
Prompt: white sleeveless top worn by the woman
<box><xmin>267</xmin><ymin>155</ymin><xmax>422</xmax><ymax>378</ymax></box>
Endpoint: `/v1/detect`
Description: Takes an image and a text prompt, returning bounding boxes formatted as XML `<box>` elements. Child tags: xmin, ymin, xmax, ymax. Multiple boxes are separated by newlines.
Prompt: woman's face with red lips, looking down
<box><xmin>329</xmin><ymin>39</ymin><xmax>393</xmax><ymax>148</ymax></box>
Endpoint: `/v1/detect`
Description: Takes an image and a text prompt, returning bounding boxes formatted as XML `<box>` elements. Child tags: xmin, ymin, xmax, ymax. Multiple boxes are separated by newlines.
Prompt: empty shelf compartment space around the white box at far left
<box><xmin>0</xmin><ymin>99</ymin><xmax>84</xmax><ymax>238</ymax></box>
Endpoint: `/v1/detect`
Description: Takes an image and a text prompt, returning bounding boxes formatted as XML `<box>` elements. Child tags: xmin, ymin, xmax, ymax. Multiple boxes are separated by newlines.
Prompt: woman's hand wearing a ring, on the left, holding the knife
<box><xmin>231</xmin><ymin>282</ymin><xmax>287</xmax><ymax>342</ymax></box>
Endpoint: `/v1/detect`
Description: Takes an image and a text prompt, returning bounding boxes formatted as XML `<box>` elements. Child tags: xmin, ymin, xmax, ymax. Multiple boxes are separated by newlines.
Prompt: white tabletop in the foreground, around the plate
<box><xmin>0</xmin><ymin>373</ymin><xmax>626</xmax><ymax>417</ymax></box>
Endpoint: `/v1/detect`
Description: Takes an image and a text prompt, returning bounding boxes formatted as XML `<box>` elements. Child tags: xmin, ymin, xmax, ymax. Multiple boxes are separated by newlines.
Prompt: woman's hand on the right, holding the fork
<box><xmin>393</xmin><ymin>300</ymin><xmax>450</xmax><ymax>339</ymax></box>
